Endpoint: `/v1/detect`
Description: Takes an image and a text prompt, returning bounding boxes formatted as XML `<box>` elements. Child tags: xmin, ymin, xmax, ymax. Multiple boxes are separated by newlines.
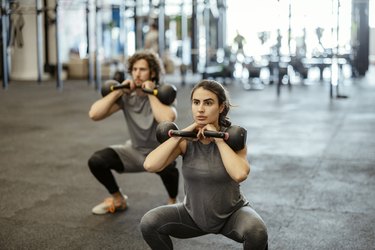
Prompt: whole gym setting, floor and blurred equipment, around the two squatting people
<box><xmin>0</xmin><ymin>0</ymin><xmax>375</xmax><ymax>250</ymax></box>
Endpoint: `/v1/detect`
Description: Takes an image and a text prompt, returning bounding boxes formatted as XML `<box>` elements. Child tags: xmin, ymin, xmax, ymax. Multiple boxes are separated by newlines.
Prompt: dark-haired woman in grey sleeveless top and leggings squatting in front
<box><xmin>140</xmin><ymin>80</ymin><xmax>268</xmax><ymax>250</ymax></box>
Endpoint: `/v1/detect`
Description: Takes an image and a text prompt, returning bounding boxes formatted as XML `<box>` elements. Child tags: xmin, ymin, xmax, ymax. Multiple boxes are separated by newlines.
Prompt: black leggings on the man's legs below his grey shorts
<box><xmin>88</xmin><ymin>148</ymin><xmax>179</xmax><ymax>198</ymax></box>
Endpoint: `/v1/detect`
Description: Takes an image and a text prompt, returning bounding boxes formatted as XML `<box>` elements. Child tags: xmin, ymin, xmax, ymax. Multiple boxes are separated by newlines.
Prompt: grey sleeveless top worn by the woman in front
<box><xmin>182</xmin><ymin>141</ymin><xmax>248</xmax><ymax>233</ymax></box>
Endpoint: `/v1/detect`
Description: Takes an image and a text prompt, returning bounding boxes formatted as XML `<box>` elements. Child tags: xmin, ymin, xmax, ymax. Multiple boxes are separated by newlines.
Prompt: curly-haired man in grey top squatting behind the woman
<box><xmin>88</xmin><ymin>51</ymin><xmax>179</xmax><ymax>214</ymax></box>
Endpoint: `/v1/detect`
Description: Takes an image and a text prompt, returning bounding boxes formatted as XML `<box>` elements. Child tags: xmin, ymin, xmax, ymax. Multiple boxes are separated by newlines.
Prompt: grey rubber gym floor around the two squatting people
<box><xmin>0</xmin><ymin>69</ymin><xmax>375</xmax><ymax>250</ymax></box>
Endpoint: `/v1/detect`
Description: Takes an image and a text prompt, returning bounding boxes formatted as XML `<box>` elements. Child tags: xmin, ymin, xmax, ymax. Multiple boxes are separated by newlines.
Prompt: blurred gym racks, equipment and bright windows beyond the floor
<box><xmin>1</xmin><ymin>0</ymin><xmax>375</xmax><ymax>90</ymax></box>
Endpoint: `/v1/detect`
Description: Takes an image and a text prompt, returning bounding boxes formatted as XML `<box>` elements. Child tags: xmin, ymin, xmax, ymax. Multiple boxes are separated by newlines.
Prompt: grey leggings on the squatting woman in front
<box><xmin>140</xmin><ymin>203</ymin><xmax>268</xmax><ymax>250</ymax></box>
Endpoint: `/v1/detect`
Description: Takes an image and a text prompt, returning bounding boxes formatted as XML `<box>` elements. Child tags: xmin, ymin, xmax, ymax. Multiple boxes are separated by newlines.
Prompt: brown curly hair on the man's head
<box><xmin>128</xmin><ymin>50</ymin><xmax>164</xmax><ymax>85</ymax></box>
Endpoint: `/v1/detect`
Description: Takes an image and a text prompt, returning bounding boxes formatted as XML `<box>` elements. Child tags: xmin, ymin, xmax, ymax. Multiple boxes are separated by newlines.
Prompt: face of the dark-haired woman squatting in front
<box><xmin>191</xmin><ymin>87</ymin><xmax>224</xmax><ymax>127</ymax></box>
